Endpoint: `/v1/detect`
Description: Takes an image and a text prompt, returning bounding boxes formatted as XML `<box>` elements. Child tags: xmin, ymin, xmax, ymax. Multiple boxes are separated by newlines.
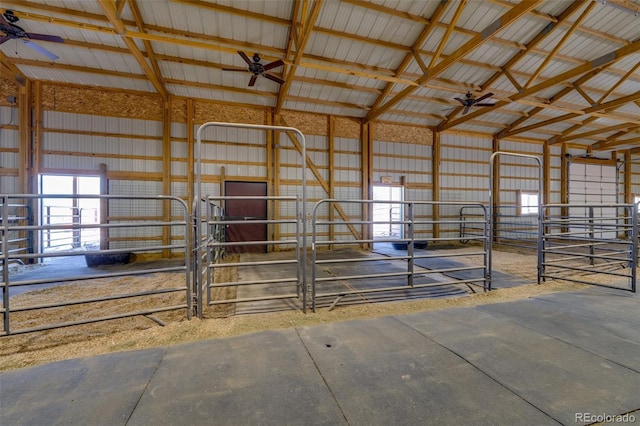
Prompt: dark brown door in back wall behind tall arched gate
<box><xmin>224</xmin><ymin>181</ymin><xmax>267</xmax><ymax>253</ymax></box>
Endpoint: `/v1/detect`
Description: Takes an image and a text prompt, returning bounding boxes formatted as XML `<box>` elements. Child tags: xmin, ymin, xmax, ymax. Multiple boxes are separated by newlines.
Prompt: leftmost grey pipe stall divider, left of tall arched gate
<box><xmin>0</xmin><ymin>194</ymin><xmax>192</xmax><ymax>335</ymax></box>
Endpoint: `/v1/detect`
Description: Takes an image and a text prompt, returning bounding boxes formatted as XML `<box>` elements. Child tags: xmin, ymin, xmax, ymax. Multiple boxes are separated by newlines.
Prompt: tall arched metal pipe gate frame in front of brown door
<box><xmin>192</xmin><ymin>121</ymin><xmax>308</xmax><ymax>319</ymax></box>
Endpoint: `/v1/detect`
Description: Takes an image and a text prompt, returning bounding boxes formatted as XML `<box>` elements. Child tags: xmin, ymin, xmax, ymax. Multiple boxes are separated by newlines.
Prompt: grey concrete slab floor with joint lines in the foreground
<box><xmin>0</xmin><ymin>288</ymin><xmax>640</xmax><ymax>426</ymax></box>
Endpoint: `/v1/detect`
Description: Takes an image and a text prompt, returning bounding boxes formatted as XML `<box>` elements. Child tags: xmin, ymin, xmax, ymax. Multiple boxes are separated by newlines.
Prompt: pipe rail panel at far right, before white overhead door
<box><xmin>539</xmin><ymin>204</ymin><xmax>638</xmax><ymax>292</ymax></box>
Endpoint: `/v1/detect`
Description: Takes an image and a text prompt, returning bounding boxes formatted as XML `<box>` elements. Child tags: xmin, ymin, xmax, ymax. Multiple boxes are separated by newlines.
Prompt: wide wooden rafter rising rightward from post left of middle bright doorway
<box><xmin>366</xmin><ymin>0</ymin><xmax>541</xmax><ymax>121</ymax></box>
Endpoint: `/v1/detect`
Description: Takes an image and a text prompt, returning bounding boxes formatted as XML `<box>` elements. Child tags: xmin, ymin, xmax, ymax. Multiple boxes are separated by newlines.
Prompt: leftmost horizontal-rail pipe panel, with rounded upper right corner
<box><xmin>0</xmin><ymin>194</ymin><xmax>192</xmax><ymax>335</ymax></box>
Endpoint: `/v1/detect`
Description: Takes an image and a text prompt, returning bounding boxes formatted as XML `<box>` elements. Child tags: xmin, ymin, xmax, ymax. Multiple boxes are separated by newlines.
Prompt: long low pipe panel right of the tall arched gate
<box><xmin>311</xmin><ymin>199</ymin><xmax>491</xmax><ymax>311</ymax></box>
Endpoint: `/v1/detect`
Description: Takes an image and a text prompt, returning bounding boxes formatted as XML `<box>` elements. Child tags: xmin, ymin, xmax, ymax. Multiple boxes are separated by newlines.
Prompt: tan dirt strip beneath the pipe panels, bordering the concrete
<box><xmin>0</xmin><ymin>248</ymin><xmax>620</xmax><ymax>371</ymax></box>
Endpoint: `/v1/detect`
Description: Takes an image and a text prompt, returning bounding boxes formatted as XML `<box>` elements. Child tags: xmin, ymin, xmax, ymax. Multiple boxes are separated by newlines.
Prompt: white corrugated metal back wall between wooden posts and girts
<box><xmin>0</xmin><ymin>87</ymin><xmax>640</xmax><ymax>255</ymax></box>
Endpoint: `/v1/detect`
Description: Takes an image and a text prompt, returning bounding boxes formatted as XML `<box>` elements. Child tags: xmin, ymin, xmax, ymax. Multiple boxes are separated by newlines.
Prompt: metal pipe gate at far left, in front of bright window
<box><xmin>0</xmin><ymin>194</ymin><xmax>192</xmax><ymax>335</ymax></box>
